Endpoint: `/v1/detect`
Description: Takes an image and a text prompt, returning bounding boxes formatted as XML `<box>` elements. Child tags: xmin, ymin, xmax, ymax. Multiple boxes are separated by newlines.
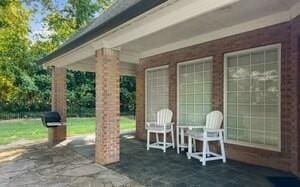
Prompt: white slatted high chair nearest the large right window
<box><xmin>188</xmin><ymin>111</ymin><xmax>226</xmax><ymax>166</ymax></box>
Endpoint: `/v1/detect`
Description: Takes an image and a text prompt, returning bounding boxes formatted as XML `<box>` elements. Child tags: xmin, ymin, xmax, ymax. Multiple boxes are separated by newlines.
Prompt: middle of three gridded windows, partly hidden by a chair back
<box><xmin>177</xmin><ymin>58</ymin><xmax>212</xmax><ymax>125</ymax></box>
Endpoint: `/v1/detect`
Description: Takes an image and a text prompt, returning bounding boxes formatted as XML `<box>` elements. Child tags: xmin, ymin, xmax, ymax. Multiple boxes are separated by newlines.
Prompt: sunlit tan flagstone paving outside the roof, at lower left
<box><xmin>0</xmin><ymin>138</ymin><xmax>140</xmax><ymax>187</ymax></box>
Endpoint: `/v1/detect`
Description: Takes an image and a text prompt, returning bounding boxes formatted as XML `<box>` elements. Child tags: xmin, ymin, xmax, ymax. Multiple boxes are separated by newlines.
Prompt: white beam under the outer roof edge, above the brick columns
<box><xmin>46</xmin><ymin>0</ymin><xmax>239</xmax><ymax>67</ymax></box>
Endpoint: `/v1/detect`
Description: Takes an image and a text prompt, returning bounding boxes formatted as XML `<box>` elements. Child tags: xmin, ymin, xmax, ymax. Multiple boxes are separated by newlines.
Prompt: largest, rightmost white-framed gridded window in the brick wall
<box><xmin>224</xmin><ymin>45</ymin><xmax>281</xmax><ymax>150</ymax></box>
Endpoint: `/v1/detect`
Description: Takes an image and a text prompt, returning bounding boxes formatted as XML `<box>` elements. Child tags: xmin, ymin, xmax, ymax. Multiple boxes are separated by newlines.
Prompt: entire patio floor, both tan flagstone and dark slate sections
<box><xmin>0</xmin><ymin>136</ymin><xmax>300</xmax><ymax>187</ymax></box>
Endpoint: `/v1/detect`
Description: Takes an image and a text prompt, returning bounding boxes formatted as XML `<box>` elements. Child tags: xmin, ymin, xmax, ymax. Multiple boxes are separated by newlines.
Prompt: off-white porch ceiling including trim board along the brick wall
<box><xmin>123</xmin><ymin>0</ymin><xmax>300</xmax><ymax>58</ymax></box>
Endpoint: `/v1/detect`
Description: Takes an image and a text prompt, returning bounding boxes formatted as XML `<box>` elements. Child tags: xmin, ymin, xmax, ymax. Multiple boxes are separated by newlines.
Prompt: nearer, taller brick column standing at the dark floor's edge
<box><xmin>95</xmin><ymin>48</ymin><xmax>120</xmax><ymax>165</ymax></box>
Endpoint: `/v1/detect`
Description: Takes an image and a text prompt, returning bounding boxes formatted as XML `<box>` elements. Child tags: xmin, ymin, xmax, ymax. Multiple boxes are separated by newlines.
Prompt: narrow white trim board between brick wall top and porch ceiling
<box><xmin>141</xmin><ymin>11</ymin><xmax>290</xmax><ymax>58</ymax></box>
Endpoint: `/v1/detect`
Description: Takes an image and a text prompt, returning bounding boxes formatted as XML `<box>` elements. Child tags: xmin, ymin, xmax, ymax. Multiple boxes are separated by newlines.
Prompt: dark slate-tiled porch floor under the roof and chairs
<box><xmin>70</xmin><ymin>134</ymin><xmax>300</xmax><ymax>187</ymax></box>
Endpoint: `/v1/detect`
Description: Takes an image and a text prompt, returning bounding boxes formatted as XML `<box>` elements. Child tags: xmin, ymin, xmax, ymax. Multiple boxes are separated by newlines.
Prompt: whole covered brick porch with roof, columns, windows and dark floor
<box><xmin>41</xmin><ymin>0</ymin><xmax>300</xmax><ymax>180</ymax></box>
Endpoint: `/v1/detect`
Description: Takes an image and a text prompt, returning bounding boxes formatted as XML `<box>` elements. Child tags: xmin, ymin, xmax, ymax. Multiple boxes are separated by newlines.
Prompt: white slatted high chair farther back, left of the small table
<box><xmin>146</xmin><ymin>109</ymin><xmax>175</xmax><ymax>152</ymax></box>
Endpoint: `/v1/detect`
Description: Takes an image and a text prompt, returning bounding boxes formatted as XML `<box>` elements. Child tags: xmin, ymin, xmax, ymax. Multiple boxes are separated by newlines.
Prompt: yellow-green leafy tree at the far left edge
<box><xmin>0</xmin><ymin>0</ymin><xmax>35</xmax><ymax>110</ymax></box>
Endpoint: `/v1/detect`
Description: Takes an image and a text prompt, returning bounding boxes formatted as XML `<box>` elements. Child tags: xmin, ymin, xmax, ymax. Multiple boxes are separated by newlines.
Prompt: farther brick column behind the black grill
<box><xmin>48</xmin><ymin>67</ymin><xmax>67</xmax><ymax>146</ymax></box>
